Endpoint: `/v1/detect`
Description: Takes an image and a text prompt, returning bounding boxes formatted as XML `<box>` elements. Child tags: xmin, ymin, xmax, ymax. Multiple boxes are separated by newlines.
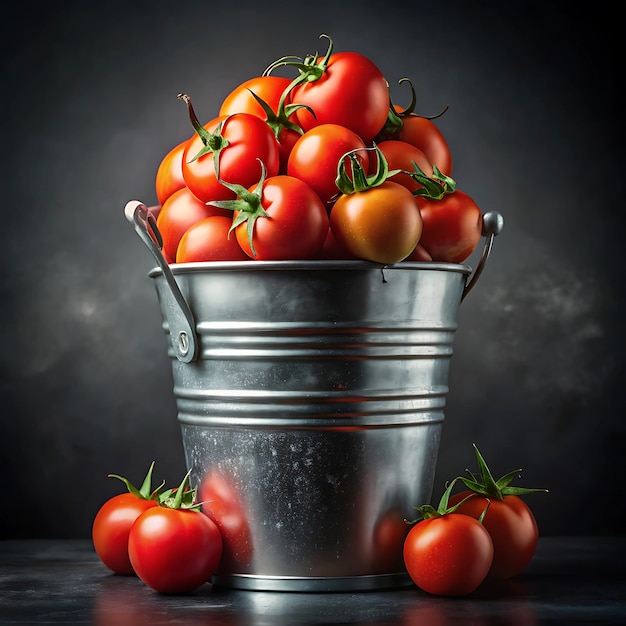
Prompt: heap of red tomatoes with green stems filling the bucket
<box><xmin>152</xmin><ymin>34</ymin><xmax>482</xmax><ymax>264</ymax></box>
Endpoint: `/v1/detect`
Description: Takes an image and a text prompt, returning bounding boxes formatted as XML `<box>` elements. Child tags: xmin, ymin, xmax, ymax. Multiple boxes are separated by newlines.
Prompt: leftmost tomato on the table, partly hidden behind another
<box><xmin>91</xmin><ymin>493</ymin><xmax>157</xmax><ymax>574</ymax></box>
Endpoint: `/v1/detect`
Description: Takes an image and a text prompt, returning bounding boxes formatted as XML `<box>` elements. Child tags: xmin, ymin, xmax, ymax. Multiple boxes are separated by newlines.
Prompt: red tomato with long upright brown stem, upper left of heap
<box><xmin>182</xmin><ymin>113</ymin><xmax>280</xmax><ymax>202</ymax></box>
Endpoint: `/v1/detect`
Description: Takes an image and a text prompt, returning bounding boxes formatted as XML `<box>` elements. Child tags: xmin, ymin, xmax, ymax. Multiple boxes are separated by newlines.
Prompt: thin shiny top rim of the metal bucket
<box><xmin>148</xmin><ymin>259</ymin><xmax>472</xmax><ymax>278</ymax></box>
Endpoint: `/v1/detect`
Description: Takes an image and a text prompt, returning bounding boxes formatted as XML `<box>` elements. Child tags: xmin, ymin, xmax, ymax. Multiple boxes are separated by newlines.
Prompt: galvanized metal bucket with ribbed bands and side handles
<box><xmin>126</xmin><ymin>202</ymin><xmax>502</xmax><ymax>591</ymax></box>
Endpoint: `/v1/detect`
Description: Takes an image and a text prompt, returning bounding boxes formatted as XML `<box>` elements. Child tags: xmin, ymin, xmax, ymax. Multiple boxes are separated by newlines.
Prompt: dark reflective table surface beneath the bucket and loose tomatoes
<box><xmin>0</xmin><ymin>536</ymin><xmax>626</xmax><ymax>626</ymax></box>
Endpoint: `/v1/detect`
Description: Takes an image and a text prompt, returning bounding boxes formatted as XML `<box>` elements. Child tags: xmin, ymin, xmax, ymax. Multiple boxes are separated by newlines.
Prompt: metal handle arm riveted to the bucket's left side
<box><xmin>124</xmin><ymin>200</ymin><xmax>198</xmax><ymax>363</ymax></box>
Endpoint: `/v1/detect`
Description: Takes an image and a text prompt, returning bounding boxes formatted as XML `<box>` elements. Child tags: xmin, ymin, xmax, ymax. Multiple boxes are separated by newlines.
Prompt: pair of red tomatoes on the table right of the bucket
<box><xmin>403</xmin><ymin>446</ymin><xmax>547</xmax><ymax>596</ymax></box>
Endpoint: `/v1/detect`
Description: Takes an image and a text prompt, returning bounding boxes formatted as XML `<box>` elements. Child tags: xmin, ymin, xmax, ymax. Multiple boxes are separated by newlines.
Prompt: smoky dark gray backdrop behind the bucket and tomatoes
<box><xmin>0</xmin><ymin>0</ymin><xmax>626</xmax><ymax>537</ymax></box>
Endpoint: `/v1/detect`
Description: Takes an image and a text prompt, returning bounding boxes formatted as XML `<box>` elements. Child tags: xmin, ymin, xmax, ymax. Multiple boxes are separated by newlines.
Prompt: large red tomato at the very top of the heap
<box><xmin>291</xmin><ymin>52</ymin><xmax>389</xmax><ymax>143</ymax></box>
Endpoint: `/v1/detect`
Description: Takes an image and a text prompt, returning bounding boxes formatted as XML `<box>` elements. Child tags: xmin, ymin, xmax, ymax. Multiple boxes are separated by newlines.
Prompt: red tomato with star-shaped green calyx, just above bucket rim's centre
<box><xmin>235</xmin><ymin>176</ymin><xmax>328</xmax><ymax>261</ymax></box>
